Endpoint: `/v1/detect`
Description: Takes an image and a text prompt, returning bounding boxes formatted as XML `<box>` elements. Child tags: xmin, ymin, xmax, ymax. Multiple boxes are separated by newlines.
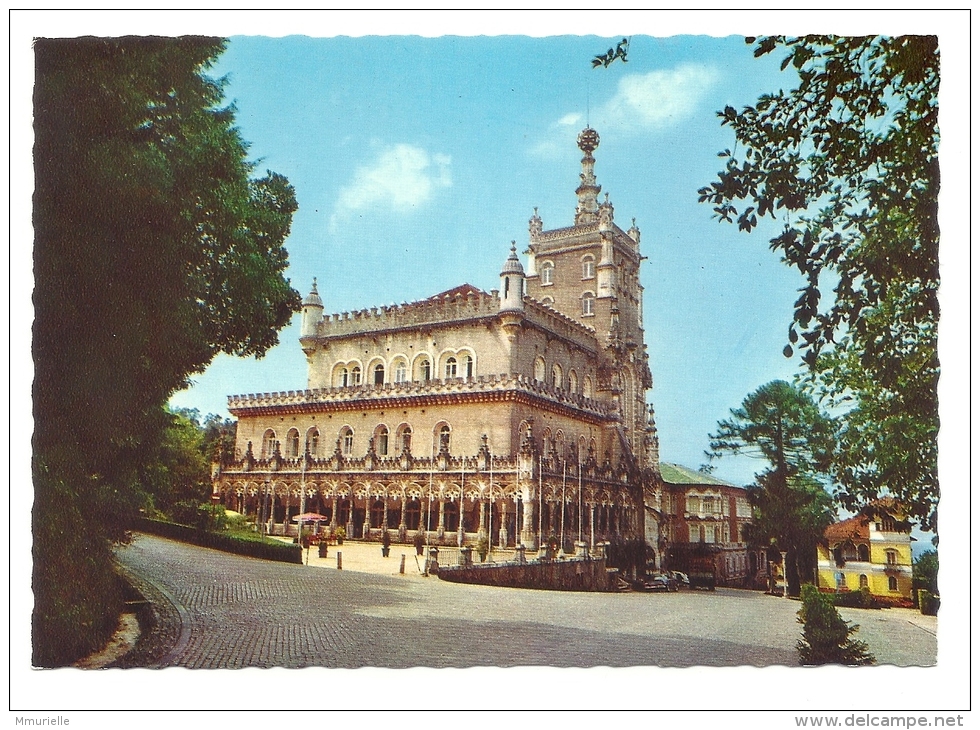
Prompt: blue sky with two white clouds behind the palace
<box><xmin>173</xmin><ymin>35</ymin><xmax>816</xmax><ymax>484</ymax></box>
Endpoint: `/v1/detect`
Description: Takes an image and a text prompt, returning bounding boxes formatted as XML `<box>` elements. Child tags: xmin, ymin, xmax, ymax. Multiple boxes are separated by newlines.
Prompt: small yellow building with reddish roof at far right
<box><xmin>817</xmin><ymin>499</ymin><xmax>912</xmax><ymax>598</ymax></box>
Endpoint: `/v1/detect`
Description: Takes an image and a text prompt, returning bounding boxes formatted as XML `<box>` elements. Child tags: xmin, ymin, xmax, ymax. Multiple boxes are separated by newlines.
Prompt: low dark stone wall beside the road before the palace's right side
<box><xmin>438</xmin><ymin>557</ymin><xmax>616</xmax><ymax>591</ymax></box>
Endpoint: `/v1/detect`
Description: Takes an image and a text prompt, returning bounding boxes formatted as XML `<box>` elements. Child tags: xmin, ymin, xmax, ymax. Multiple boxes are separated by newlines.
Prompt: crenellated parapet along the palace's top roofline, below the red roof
<box><xmin>306</xmin><ymin>290</ymin><xmax>500</xmax><ymax>338</ymax></box>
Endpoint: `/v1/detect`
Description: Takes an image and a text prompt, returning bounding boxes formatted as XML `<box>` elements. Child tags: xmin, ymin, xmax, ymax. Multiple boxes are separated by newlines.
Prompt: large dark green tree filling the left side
<box><xmin>33</xmin><ymin>37</ymin><xmax>299</xmax><ymax>664</ymax></box>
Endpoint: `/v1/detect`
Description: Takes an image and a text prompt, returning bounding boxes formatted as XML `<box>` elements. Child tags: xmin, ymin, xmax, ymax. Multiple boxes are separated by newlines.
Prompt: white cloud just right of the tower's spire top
<box><xmin>597</xmin><ymin>64</ymin><xmax>719</xmax><ymax>130</ymax></box>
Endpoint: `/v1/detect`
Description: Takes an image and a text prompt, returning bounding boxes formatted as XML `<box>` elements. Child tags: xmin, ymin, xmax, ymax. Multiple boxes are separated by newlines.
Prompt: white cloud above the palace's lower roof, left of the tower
<box><xmin>330</xmin><ymin>144</ymin><xmax>452</xmax><ymax>228</ymax></box>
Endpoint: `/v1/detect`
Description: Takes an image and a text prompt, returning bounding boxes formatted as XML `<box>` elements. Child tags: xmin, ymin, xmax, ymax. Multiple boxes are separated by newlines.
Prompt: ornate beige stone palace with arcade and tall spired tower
<box><xmin>214</xmin><ymin>128</ymin><xmax>760</xmax><ymax>576</ymax></box>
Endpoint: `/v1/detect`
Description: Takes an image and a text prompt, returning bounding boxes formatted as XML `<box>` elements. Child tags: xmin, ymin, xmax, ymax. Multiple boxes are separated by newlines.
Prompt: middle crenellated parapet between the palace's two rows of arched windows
<box><xmin>228</xmin><ymin>374</ymin><xmax>611</xmax><ymax>424</ymax></box>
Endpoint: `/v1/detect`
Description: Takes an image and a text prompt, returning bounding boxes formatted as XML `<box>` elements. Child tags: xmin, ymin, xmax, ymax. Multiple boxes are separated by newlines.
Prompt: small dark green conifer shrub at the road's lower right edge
<box><xmin>796</xmin><ymin>584</ymin><xmax>875</xmax><ymax>666</ymax></box>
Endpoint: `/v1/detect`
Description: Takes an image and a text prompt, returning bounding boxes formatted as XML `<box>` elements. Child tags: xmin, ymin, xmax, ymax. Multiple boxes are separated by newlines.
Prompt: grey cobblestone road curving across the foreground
<box><xmin>118</xmin><ymin>535</ymin><xmax>936</xmax><ymax>668</ymax></box>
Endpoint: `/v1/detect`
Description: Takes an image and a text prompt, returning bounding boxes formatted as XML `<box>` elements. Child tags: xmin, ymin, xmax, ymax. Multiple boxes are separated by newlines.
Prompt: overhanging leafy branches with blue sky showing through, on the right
<box><xmin>699</xmin><ymin>36</ymin><xmax>939</xmax><ymax>531</ymax></box>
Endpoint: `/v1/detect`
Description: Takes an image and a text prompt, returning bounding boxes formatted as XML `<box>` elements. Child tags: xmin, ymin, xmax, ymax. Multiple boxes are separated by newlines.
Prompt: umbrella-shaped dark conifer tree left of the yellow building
<box><xmin>708</xmin><ymin>380</ymin><xmax>834</xmax><ymax>594</ymax></box>
